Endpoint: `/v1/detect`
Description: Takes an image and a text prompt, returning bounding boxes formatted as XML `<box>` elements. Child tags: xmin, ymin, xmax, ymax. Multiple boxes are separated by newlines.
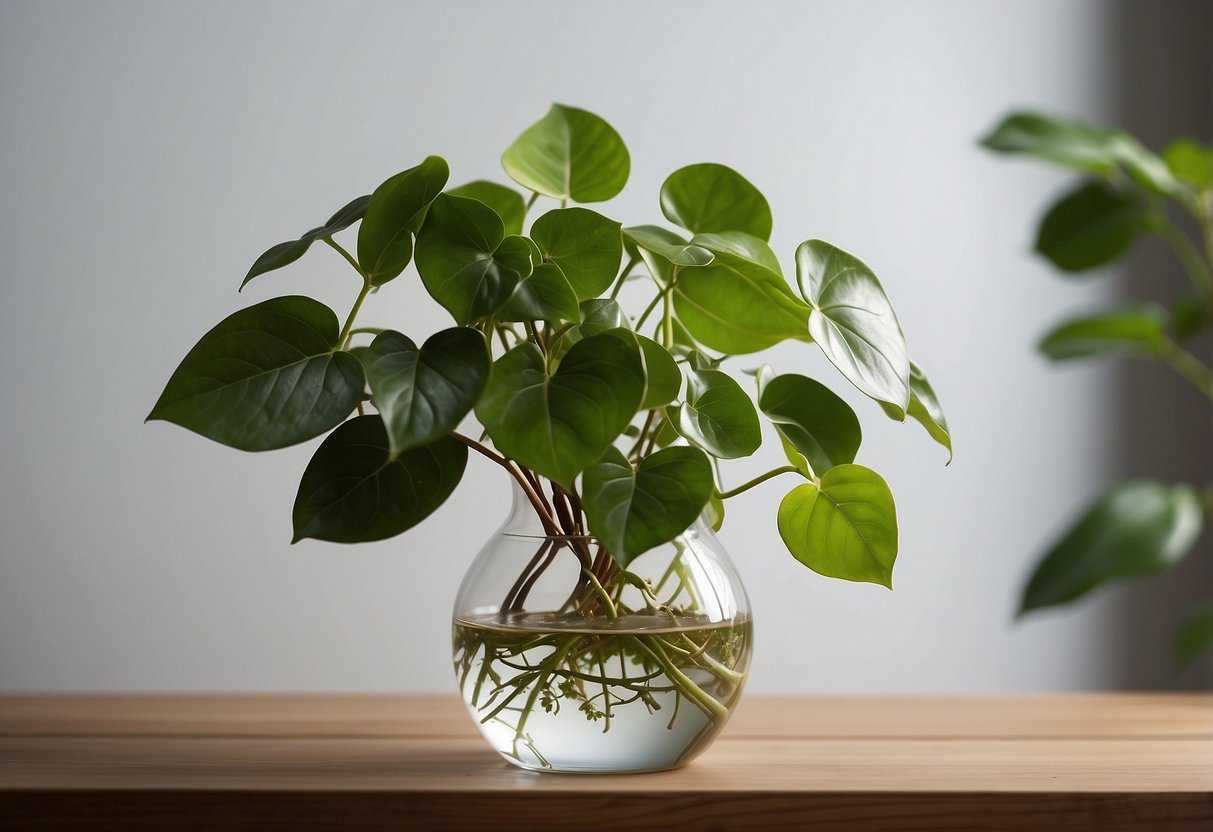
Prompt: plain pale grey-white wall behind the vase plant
<box><xmin>0</xmin><ymin>0</ymin><xmax>1203</xmax><ymax>693</ymax></box>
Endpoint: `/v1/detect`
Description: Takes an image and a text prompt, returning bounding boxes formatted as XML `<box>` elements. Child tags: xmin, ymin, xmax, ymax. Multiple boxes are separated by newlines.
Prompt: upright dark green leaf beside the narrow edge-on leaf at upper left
<box><xmin>358</xmin><ymin>156</ymin><xmax>450</xmax><ymax>286</ymax></box>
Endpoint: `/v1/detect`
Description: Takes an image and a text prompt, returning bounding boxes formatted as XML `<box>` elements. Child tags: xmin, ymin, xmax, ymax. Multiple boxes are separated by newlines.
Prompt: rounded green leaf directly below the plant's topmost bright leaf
<box><xmin>530</xmin><ymin>207</ymin><xmax>623</xmax><ymax>301</ymax></box>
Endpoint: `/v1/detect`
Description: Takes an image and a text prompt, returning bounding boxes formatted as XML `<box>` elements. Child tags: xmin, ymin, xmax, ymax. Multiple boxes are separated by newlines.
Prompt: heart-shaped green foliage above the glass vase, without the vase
<box><xmin>149</xmin><ymin>106</ymin><xmax>951</xmax><ymax>596</ymax></box>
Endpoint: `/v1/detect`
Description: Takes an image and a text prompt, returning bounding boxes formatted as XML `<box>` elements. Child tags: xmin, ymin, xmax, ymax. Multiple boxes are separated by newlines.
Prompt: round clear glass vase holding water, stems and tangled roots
<box><xmin>454</xmin><ymin>484</ymin><xmax>752</xmax><ymax>773</ymax></box>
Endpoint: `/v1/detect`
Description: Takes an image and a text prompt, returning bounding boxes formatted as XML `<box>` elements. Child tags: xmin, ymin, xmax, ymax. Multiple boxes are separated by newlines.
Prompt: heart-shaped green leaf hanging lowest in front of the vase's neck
<box><xmin>582</xmin><ymin>448</ymin><xmax>712</xmax><ymax>566</ymax></box>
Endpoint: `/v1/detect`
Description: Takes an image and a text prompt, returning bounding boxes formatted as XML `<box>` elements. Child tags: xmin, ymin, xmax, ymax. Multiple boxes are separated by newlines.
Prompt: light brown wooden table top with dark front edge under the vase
<box><xmin>0</xmin><ymin>695</ymin><xmax>1213</xmax><ymax>832</ymax></box>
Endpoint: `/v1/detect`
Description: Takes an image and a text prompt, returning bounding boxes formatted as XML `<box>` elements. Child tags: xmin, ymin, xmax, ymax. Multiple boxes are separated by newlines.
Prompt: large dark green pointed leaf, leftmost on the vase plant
<box><xmin>148</xmin><ymin>296</ymin><xmax>366</xmax><ymax>451</ymax></box>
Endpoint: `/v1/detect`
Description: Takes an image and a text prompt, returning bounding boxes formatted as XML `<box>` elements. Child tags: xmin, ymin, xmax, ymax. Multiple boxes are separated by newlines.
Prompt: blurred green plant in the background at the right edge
<box><xmin>983</xmin><ymin>113</ymin><xmax>1213</xmax><ymax>665</ymax></box>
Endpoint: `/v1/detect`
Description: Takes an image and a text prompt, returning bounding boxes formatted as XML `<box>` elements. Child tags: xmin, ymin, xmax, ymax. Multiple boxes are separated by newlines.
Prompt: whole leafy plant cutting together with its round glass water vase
<box><xmin>149</xmin><ymin>106</ymin><xmax>951</xmax><ymax>771</ymax></box>
